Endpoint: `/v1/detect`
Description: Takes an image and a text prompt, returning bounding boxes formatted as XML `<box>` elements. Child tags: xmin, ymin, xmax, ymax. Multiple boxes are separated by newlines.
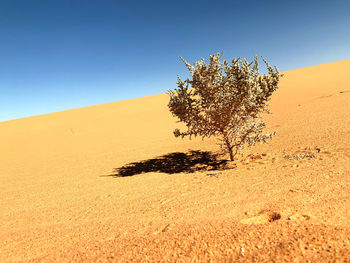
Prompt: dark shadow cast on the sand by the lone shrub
<box><xmin>107</xmin><ymin>151</ymin><xmax>228</xmax><ymax>177</ymax></box>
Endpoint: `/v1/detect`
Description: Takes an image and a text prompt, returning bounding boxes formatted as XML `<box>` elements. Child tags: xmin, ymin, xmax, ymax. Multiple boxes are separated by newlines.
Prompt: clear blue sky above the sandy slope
<box><xmin>0</xmin><ymin>0</ymin><xmax>350</xmax><ymax>121</ymax></box>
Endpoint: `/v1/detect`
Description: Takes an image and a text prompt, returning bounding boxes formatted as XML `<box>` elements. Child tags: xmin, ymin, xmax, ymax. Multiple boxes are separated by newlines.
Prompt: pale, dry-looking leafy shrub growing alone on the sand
<box><xmin>168</xmin><ymin>53</ymin><xmax>282</xmax><ymax>161</ymax></box>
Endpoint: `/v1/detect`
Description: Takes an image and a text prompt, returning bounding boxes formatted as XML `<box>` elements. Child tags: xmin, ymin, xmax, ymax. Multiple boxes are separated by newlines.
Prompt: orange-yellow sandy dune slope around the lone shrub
<box><xmin>0</xmin><ymin>60</ymin><xmax>350</xmax><ymax>262</ymax></box>
